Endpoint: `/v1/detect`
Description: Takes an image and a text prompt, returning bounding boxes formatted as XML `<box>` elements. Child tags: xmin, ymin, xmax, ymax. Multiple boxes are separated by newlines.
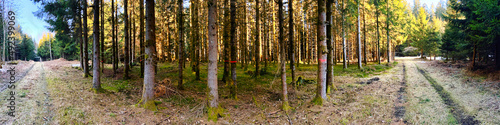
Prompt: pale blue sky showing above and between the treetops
<box><xmin>7</xmin><ymin>0</ymin><xmax>439</xmax><ymax>44</ymax></box>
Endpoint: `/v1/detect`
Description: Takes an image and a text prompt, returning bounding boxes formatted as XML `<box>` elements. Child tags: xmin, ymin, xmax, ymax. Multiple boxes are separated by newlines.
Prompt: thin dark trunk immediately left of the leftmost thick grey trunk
<box><xmin>83</xmin><ymin>0</ymin><xmax>90</xmax><ymax>78</ymax></box>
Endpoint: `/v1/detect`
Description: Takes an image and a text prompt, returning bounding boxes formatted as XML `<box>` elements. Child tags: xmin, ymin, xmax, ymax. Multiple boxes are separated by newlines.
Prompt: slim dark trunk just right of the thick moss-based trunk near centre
<box><xmin>230</xmin><ymin>0</ymin><xmax>238</xmax><ymax>99</ymax></box>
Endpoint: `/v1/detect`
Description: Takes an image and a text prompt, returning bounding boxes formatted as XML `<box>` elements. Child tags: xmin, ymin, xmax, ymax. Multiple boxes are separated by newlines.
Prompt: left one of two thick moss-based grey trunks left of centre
<box><xmin>141</xmin><ymin>0</ymin><xmax>156</xmax><ymax>110</ymax></box>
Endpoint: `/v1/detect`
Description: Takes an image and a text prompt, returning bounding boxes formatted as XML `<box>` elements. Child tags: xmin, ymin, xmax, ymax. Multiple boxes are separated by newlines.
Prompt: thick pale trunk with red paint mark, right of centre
<box><xmin>315</xmin><ymin>0</ymin><xmax>328</xmax><ymax>104</ymax></box>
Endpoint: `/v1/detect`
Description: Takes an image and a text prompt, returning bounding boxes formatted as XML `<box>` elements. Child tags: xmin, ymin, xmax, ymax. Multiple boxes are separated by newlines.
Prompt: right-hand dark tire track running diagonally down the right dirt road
<box><xmin>415</xmin><ymin>64</ymin><xmax>480</xmax><ymax>125</ymax></box>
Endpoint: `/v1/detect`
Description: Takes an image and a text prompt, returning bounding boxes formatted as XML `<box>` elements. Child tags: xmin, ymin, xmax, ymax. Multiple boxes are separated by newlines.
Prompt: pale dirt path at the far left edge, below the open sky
<box><xmin>0</xmin><ymin>62</ymin><xmax>52</xmax><ymax>124</ymax></box>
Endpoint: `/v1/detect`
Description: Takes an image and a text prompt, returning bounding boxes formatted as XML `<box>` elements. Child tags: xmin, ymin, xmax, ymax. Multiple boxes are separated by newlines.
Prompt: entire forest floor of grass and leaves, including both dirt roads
<box><xmin>0</xmin><ymin>57</ymin><xmax>500</xmax><ymax>124</ymax></box>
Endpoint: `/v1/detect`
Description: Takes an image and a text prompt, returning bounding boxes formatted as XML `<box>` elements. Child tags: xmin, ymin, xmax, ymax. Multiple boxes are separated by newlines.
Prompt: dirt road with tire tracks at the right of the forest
<box><xmin>398</xmin><ymin>58</ymin><xmax>500</xmax><ymax>125</ymax></box>
